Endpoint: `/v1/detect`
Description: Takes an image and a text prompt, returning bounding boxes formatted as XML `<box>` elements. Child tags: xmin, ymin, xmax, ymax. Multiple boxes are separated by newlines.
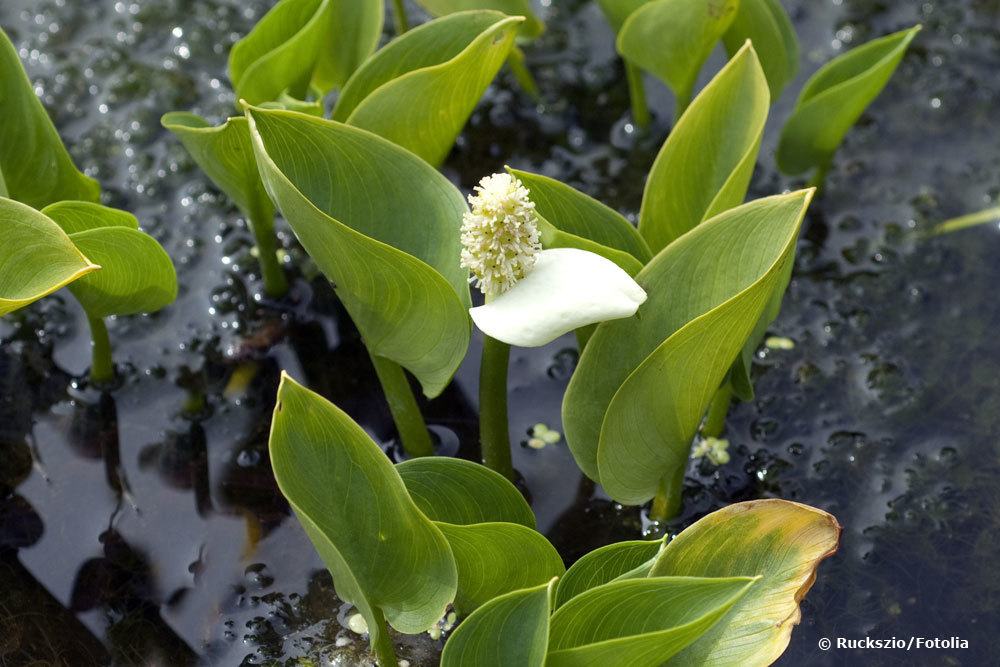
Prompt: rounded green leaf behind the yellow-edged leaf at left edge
<box><xmin>42</xmin><ymin>202</ymin><xmax>177</xmax><ymax>317</ymax></box>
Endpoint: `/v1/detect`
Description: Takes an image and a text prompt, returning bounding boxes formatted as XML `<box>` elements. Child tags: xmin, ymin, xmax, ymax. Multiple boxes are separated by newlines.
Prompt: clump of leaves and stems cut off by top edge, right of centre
<box><xmin>599</xmin><ymin>0</ymin><xmax>799</xmax><ymax>127</ymax></box>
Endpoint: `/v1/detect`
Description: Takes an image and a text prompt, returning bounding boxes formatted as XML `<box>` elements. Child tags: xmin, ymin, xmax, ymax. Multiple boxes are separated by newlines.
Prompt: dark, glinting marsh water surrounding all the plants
<box><xmin>0</xmin><ymin>0</ymin><xmax>1000</xmax><ymax>666</ymax></box>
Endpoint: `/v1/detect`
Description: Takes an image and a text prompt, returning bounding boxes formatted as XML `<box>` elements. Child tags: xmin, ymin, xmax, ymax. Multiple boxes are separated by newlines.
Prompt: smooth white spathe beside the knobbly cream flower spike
<box><xmin>469</xmin><ymin>248</ymin><xmax>646</xmax><ymax>347</ymax></box>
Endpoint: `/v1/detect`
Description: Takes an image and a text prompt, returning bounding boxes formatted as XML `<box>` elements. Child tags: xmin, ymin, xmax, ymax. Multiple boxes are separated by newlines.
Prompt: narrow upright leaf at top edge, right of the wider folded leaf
<box><xmin>312</xmin><ymin>0</ymin><xmax>385</xmax><ymax>93</ymax></box>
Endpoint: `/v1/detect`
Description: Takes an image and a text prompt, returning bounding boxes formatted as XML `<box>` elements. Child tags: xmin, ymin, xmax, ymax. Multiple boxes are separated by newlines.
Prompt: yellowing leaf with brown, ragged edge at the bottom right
<box><xmin>650</xmin><ymin>500</ymin><xmax>840</xmax><ymax>667</ymax></box>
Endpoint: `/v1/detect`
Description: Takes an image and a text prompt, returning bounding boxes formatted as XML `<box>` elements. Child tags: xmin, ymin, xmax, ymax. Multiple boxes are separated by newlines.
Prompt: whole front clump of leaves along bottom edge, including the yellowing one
<box><xmin>270</xmin><ymin>375</ymin><xmax>840</xmax><ymax>667</ymax></box>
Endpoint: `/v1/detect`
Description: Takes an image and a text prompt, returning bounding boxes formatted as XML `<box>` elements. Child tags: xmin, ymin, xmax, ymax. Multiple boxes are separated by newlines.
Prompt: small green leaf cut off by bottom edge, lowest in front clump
<box><xmin>441</xmin><ymin>582</ymin><xmax>554</xmax><ymax>667</ymax></box>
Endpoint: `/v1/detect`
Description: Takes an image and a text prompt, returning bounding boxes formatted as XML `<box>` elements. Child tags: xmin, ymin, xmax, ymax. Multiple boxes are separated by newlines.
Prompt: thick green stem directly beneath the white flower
<box><xmin>479</xmin><ymin>336</ymin><xmax>514</xmax><ymax>480</ymax></box>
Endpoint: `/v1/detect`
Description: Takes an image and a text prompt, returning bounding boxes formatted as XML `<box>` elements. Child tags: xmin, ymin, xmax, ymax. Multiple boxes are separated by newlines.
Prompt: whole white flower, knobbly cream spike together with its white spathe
<box><xmin>462</xmin><ymin>173</ymin><xmax>646</xmax><ymax>347</ymax></box>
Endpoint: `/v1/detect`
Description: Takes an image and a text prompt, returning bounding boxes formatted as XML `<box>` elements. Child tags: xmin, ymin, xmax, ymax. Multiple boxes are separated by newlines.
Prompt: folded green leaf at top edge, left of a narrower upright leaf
<box><xmin>229</xmin><ymin>0</ymin><xmax>337</xmax><ymax>104</ymax></box>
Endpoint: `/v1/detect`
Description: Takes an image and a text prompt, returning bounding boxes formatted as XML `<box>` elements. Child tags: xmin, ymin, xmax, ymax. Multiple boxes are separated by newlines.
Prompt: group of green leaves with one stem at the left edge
<box><xmin>0</xmin><ymin>31</ymin><xmax>177</xmax><ymax>383</ymax></box>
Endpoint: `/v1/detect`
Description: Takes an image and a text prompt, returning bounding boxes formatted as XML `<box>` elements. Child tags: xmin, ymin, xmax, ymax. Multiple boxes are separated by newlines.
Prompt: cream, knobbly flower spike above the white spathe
<box><xmin>461</xmin><ymin>173</ymin><xmax>542</xmax><ymax>296</ymax></box>
